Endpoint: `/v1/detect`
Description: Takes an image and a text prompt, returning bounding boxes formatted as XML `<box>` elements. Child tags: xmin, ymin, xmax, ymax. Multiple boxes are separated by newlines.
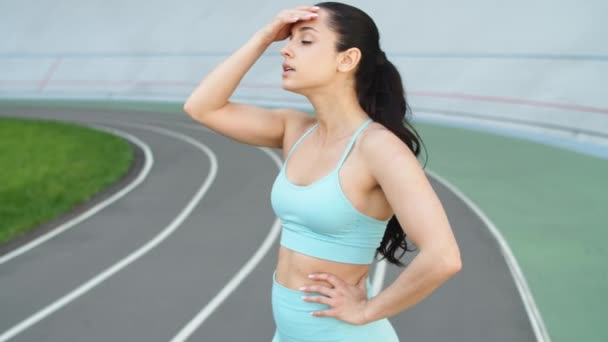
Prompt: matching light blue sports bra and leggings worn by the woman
<box><xmin>271</xmin><ymin>119</ymin><xmax>399</xmax><ymax>342</ymax></box>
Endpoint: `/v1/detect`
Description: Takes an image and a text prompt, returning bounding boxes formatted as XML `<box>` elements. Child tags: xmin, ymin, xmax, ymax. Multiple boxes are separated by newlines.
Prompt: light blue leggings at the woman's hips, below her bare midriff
<box><xmin>272</xmin><ymin>271</ymin><xmax>399</xmax><ymax>342</ymax></box>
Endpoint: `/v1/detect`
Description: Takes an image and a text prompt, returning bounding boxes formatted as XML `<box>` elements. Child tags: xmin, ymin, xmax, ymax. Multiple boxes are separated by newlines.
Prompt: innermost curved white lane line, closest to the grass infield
<box><xmin>0</xmin><ymin>127</ymin><xmax>154</xmax><ymax>265</ymax></box>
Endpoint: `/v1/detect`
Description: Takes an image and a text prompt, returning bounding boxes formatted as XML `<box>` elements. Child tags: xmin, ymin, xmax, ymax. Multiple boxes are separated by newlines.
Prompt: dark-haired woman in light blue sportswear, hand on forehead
<box><xmin>184</xmin><ymin>2</ymin><xmax>461</xmax><ymax>342</ymax></box>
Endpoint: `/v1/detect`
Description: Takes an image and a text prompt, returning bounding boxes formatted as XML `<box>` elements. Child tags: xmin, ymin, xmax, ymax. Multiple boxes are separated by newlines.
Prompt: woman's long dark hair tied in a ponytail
<box><xmin>316</xmin><ymin>2</ymin><xmax>426</xmax><ymax>267</ymax></box>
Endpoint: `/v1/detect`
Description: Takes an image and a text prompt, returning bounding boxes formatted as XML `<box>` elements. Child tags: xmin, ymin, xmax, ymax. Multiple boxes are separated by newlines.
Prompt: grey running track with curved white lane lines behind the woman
<box><xmin>0</xmin><ymin>106</ymin><xmax>536</xmax><ymax>342</ymax></box>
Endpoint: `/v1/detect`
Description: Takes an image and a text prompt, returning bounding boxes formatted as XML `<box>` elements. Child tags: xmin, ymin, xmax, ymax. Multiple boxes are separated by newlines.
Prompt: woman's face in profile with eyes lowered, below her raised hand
<box><xmin>281</xmin><ymin>9</ymin><xmax>337</xmax><ymax>94</ymax></box>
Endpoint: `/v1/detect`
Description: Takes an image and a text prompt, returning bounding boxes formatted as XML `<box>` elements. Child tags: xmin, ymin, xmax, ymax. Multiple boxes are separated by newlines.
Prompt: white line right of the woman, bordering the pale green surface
<box><xmin>425</xmin><ymin>169</ymin><xmax>551</xmax><ymax>342</ymax></box>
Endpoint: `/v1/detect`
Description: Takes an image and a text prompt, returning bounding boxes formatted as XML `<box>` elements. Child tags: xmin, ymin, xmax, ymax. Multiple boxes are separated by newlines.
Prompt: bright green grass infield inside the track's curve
<box><xmin>0</xmin><ymin>118</ymin><xmax>133</xmax><ymax>243</ymax></box>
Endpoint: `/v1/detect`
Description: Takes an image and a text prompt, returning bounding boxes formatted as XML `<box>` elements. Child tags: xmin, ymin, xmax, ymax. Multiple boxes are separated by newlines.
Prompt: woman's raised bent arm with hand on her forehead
<box><xmin>183</xmin><ymin>7</ymin><xmax>317</xmax><ymax>147</ymax></box>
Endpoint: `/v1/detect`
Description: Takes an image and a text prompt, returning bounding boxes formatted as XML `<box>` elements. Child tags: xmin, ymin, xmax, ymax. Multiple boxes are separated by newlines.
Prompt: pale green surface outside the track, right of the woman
<box><xmin>415</xmin><ymin>124</ymin><xmax>608</xmax><ymax>342</ymax></box>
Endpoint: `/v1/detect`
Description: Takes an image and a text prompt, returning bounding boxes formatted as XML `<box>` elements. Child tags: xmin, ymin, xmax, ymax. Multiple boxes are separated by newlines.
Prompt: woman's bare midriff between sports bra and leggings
<box><xmin>276</xmin><ymin>246</ymin><xmax>370</xmax><ymax>291</ymax></box>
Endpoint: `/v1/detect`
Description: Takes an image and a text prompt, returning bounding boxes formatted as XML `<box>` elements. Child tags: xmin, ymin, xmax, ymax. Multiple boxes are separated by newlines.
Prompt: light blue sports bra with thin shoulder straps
<box><xmin>270</xmin><ymin>118</ymin><xmax>389</xmax><ymax>264</ymax></box>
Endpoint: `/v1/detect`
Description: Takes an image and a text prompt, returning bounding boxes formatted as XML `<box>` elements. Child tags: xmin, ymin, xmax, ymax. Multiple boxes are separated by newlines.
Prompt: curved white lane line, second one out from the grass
<box><xmin>0</xmin><ymin>123</ymin><xmax>217</xmax><ymax>342</ymax></box>
